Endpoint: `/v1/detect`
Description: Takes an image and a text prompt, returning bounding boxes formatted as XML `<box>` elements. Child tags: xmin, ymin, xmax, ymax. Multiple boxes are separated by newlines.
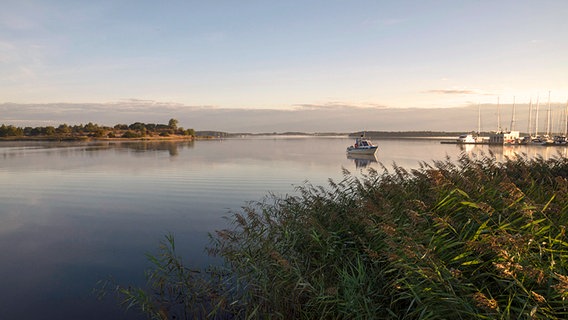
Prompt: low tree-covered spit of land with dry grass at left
<box><xmin>0</xmin><ymin>119</ymin><xmax>195</xmax><ymax>138</ymax></box>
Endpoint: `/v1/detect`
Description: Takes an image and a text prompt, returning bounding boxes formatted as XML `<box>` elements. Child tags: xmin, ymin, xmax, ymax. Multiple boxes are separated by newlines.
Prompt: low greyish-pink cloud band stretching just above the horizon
<box><xmin>0</xmin><ymin>101</ymin><xmax>540</xmax><ymax>133</ymax></box>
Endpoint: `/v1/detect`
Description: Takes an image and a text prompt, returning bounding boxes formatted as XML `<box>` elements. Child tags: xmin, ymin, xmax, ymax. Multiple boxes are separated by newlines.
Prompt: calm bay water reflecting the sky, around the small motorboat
<box><xmin>0</xmin><ymin>137</ymin><xmax>566</xmax><ymax>319</ymax></box>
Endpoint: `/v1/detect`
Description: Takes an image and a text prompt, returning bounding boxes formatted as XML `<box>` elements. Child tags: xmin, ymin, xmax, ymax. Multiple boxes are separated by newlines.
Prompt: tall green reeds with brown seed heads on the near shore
<box><xmin>104</xmin><ymin>154</ymin><xmax>568</xmax><ymax>319</ymax></box>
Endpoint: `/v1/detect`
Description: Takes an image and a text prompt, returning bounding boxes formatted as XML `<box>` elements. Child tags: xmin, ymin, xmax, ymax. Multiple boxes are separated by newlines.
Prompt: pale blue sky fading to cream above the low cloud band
<box><xmin>0</xmin><ymin>0</ymin><xmax>568</xmax><ymax>131</ymax></box>
